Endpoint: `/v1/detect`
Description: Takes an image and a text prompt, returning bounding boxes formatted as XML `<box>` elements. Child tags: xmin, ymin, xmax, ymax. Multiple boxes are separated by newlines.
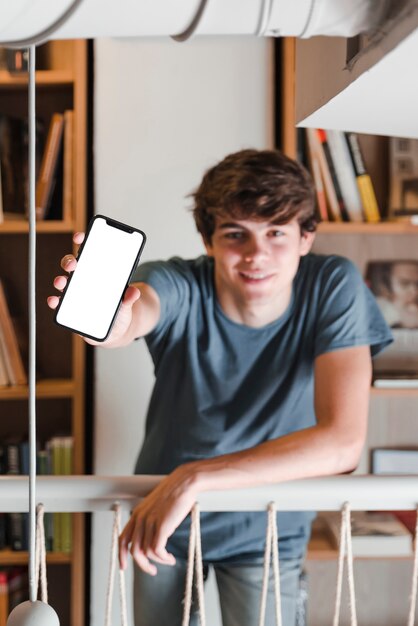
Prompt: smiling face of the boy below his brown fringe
<box><xmin>202</xmin><ymin>217</ymin><xmax>314</xmax><ymax>306</ymax></box>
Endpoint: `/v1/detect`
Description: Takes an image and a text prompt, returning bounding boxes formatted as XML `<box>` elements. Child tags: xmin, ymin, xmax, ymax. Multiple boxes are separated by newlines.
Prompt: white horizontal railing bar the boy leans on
<box><xmin>0</xmin><ymin>475</ymin><xmax>418</xmax><ymax>512</ymax></box>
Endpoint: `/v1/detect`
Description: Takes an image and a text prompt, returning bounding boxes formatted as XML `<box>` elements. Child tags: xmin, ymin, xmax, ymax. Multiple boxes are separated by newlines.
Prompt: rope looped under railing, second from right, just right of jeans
<box><xmin>333</xmin><ymin>502</ymin><xmax>357</xmax><ymax>626</ymax></box>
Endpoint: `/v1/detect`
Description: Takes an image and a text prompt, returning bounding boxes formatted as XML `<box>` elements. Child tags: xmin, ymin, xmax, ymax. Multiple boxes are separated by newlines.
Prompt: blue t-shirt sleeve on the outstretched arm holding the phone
<box><xmin>132</xmin><ymin>257</ymin><xmax>190</xmax><ymax>335</ymax></box>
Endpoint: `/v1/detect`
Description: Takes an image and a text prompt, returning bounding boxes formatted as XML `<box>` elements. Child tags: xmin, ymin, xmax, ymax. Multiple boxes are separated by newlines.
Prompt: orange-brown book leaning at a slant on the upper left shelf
<box><xmin>35</xmin><ymin>113</ymin><xmax>64</xmax><ymax>220</ymax></box>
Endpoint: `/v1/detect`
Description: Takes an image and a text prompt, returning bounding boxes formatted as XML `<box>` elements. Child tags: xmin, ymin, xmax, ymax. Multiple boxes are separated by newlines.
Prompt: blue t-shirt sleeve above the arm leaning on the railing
<box><xmin>315</xmin><ymin>257</ymin><xmax>393</xmax><ymax>357</ymax></box>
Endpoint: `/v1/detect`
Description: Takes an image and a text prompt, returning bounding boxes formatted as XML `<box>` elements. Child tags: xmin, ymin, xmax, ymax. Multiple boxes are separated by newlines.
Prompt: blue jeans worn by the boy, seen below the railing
<box><xmin>134</xmin><ymin>558</ymin><xmax>302</xmax><ymax>626</ymax></box>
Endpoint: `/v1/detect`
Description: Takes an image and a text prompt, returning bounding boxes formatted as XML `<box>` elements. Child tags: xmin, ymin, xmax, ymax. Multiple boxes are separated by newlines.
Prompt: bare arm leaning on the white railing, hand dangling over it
<box><xmin>120</xmin><ymin>346</ymin><xmax>371</xmax><ymax>574</ymax></box>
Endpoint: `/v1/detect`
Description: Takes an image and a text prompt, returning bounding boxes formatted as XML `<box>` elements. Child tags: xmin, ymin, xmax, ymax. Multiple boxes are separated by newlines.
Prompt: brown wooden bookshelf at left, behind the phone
<box><xmin>0</xmin><ymin>40</ymin><xmax>87</xmax><ymax>626</ymax></box>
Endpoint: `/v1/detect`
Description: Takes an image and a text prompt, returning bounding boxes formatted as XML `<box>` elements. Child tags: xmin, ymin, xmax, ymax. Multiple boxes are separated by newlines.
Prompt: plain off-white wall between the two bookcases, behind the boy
<box><xmin>90</xmin><ymin>37</ymin><xmax>273</xmax><ymax>626</ymax></box>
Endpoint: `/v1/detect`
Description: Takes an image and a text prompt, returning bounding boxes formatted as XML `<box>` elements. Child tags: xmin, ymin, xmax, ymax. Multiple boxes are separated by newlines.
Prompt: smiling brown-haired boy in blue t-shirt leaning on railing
<box><xmin>49</xmin><ymin>150</ymin><xmax>391</xmax><ymax>626</ymax></box>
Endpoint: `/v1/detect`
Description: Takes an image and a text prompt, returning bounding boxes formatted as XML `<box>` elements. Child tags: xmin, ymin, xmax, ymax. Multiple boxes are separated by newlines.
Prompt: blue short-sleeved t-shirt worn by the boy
<box><xmin>135</xmin><ymin>254</ymin><xmax>391</xmax><ymax>562</ymax></box>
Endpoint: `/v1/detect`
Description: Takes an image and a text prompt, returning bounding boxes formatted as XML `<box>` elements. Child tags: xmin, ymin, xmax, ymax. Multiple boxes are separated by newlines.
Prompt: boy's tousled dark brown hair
<box><xmin>190</xmin><ymin>149</ymin><xmax>317</xmax><ymax>244</ymax></box>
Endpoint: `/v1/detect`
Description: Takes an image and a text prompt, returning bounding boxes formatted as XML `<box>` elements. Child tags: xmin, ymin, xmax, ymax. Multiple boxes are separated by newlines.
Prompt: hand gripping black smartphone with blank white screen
<box><xmin>48</xmin><ymin>216</ymin><xmax>145</xmax><ymax>347</ymax></box>
